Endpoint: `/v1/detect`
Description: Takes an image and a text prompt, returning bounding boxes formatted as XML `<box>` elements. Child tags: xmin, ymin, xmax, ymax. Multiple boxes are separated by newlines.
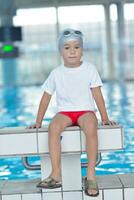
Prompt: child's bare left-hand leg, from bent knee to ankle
<box><xmin>48</xmin><ymin>113</ymin><xmax>72</xmax><ymax>180</ymax></box>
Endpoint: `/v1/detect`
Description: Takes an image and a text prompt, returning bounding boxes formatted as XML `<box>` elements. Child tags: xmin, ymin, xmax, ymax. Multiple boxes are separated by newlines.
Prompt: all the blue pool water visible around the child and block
<box><xmin>0</xmin><ymin>82</ymin><xmax>134</xmax><ymax>179</ymax></box>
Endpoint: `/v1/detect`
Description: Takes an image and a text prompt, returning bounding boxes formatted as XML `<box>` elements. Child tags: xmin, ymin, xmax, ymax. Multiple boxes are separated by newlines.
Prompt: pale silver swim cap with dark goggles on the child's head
<box><xmin>58</xmin><ymin>29</ymin><xmax>83</xmax><ymax>50</ymax></box>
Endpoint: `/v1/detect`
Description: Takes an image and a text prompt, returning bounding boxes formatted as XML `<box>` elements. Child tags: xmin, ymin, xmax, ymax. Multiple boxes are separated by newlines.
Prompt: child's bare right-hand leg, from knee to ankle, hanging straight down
<box><xmin>78</xmin><ymin>112</ymin><xmax>98</xmax><ymax>194</ymax></box>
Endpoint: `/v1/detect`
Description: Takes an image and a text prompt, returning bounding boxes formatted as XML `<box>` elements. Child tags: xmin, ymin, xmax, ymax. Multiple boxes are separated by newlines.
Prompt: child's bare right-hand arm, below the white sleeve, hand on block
<box><xmin>91</xmin><ymin>87</ymin><xmax>116</xmax><ymax>125</ymax></box>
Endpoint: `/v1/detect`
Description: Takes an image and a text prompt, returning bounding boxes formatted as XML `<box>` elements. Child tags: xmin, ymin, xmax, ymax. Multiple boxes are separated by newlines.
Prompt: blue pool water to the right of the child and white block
<box><xmin>97</xmin><ymin>82</ymin><xmax>134</xmax><ymax>174</ymax></box>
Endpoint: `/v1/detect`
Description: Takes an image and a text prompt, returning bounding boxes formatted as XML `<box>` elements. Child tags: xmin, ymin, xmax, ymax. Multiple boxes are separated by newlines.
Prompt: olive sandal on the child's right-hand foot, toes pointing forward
<box><xmin>85</xmin><ymin>177</ymin><xmax>99</xmax><ymax>197</ymax></box>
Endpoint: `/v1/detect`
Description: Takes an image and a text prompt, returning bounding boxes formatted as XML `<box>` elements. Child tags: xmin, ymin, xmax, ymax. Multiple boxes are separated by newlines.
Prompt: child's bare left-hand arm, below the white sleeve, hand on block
<box><xmin>29</xmin><ymin>92</ymin><xmax>52</xmax><ymax>128</ymax></box>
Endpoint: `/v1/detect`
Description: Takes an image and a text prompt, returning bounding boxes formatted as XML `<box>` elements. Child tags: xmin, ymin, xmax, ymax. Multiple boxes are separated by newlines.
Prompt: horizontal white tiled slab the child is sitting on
<box><xmin>0</xmin><ymin>126</ymin><xmax>123</xmax><ymax>157</ymax></box>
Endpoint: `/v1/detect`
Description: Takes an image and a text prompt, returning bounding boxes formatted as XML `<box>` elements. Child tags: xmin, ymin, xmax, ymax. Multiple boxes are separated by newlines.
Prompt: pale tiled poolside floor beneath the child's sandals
<box><xmin>0</xmin><ymin>174</ymin><xmax>134</xmax><ymax>200</ymax></box>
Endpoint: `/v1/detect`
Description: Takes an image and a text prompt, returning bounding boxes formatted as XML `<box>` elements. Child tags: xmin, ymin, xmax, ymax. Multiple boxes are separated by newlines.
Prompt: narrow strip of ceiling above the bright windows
<box><xmin>0</xmin><ymin>0</ymin><xmax>134</xmax><ymax>16</ymax></box>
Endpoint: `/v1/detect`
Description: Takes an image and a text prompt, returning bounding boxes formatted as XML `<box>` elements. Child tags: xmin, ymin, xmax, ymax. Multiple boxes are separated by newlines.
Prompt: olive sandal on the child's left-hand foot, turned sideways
<box><xmin>37</xmin><ymin>177</ymin><xmax>62</xmax><ymax>189</ymax></box>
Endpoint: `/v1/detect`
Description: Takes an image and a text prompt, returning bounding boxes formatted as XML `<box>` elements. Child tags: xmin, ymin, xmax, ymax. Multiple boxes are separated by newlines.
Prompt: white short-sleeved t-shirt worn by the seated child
<box><xmin>42</xmin><ymin>62</ymin><xmax>102</xmax><ymax>112</ymax></box>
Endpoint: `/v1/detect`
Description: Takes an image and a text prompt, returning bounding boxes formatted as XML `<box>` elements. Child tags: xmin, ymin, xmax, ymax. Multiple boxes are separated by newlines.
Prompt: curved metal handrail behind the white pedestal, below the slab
<box><xmin>22</xmin><ymin>152</ymin><xmax>102</xmax><ymax>170</ymax></box>
